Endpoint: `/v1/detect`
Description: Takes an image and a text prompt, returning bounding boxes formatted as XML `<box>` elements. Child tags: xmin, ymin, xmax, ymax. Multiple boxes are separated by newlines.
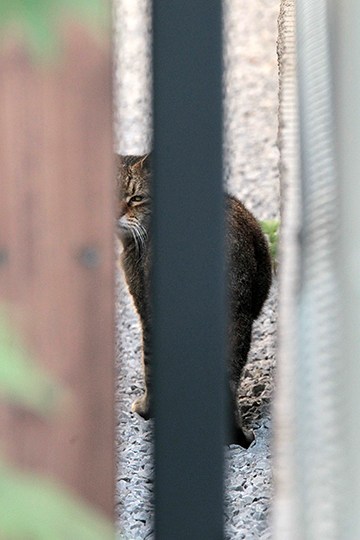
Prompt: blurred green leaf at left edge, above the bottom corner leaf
<box><xmin>0</xmin><ymin>314</ymin><xmax>62</xmax><ymax>415</ymax></box>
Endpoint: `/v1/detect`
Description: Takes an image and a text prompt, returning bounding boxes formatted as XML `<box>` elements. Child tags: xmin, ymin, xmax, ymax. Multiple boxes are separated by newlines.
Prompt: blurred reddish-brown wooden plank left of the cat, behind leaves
<box><xmin>0</xmin><ymin>20</ymin><xmax>114</xmax><ymax>514</ymax></box>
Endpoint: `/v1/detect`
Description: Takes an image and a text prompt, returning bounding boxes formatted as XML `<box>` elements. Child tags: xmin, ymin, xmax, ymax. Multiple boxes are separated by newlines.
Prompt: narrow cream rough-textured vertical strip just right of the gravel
<box><xmin>273</xmin><ymin>0</ymin><xmax>303</xmax><ymax>540</ymax></box>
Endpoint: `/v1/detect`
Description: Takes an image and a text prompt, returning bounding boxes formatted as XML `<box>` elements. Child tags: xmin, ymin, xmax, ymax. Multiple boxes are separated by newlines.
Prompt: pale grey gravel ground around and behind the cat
<box><xmin>115</xmin><ymin>0</ymin><xmax>279</xmax><ymax>540</ymax></box>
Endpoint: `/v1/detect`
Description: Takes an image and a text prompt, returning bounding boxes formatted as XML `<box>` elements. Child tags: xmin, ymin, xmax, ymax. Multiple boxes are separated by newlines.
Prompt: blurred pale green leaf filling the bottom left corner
<box><xmin>0</xmin><ymin>463</ymin><xmax>114</xmax><ymax>540</ymax></box>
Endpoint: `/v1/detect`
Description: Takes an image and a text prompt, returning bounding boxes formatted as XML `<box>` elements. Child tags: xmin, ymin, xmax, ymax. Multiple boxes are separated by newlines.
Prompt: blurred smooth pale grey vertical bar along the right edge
<box><xmin>329</xmin><ymin>0</ymin><xmax>360</xmax><ymax>540</ymax></box>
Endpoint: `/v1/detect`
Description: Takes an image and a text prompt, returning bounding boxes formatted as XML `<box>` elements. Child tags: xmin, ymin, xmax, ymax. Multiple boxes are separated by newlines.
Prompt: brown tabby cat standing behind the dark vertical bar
<box><xmin>116</xmin><ymin>154</ymin><xmax>272</xmax><ymax>448</ymax></box>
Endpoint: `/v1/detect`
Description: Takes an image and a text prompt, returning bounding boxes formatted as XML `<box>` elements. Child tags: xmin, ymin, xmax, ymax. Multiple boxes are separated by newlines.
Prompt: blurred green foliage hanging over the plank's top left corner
<box><xmin>0</xmin><ymin>0</ymin><xmax>109</xmax><ymax>59</ymax></box>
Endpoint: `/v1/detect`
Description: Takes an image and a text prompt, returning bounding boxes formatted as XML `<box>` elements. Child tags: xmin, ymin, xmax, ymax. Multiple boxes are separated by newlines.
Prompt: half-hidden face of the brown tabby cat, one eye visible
<box><xmin>116</xmin><ymin>154</ymin><xmax>151</xmax><ymax>248</ymax></box>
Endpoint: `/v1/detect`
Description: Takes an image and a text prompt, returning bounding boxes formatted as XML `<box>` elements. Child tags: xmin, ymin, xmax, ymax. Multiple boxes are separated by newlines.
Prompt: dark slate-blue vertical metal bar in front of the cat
<box><xmin>153</xmin><ymin>0</ymin><xmax>225</xmax><ymax>540</ymax></box>
